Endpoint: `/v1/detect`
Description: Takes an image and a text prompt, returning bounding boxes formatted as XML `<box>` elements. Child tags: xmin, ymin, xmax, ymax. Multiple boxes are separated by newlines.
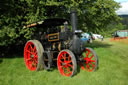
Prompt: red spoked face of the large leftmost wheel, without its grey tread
<box><xmin>24</xmin><ymin>42</ymin><xmax>38</xmax><ymax>71</ymax></box>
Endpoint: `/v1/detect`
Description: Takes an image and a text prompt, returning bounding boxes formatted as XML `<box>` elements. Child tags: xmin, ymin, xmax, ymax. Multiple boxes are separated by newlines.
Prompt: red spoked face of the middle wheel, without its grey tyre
<box><xmin>57</xmin><ymin>51</ymin><xmax>73</xmax><ymax>77</ymax></box>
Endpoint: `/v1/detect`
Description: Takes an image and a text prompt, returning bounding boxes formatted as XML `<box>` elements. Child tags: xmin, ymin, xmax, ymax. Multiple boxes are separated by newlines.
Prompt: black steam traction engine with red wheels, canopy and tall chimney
<box><xmin>24</xmin><ymin>11</ymin><xmax>98</xmax><ymax>77</ymax></box>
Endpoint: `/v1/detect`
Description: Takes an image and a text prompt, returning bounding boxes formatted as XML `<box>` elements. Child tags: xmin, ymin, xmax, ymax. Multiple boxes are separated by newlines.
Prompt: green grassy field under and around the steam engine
<box><xmin>0</xmin><ymin>39</ymin><xmax>128</xmax><ymax>85</ymax></box>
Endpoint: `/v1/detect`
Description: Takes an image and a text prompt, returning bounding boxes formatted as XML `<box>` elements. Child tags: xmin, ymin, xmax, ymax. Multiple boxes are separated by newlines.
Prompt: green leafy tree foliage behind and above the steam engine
<box><xmin>0</xmin><ymin>0</ymin><xmax>120</xmax><ymax>45</ymax></box>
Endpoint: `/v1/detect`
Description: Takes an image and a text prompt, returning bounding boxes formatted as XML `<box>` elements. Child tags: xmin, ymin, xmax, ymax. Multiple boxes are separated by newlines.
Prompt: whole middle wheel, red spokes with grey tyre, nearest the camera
<box><xmin>57</xmin><ymin>50</ymin><xmax>77</xmax><ymax>77</ymax></box>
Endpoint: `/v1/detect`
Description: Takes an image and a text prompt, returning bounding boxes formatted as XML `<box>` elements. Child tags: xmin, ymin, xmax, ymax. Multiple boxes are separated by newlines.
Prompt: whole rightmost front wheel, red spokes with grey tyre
<box><xmin>80</xmin><ymin>48</ymin><xmax>98</xmax><ymax>72</ymax></box>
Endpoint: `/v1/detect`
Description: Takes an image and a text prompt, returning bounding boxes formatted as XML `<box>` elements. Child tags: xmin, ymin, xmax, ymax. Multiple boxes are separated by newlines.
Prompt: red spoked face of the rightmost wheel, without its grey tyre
<box><xmin>80</xmin><ymin>48</ymin><xmax>96</xmax><ymax>72</ymax></box>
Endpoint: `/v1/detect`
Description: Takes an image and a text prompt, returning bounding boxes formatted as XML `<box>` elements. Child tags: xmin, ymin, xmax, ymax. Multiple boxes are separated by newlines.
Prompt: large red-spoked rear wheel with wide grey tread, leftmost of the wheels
<box><xmin>24</xmin><ymin>40</ymin><xmax>43</xmax><ymax>71</ymax></box>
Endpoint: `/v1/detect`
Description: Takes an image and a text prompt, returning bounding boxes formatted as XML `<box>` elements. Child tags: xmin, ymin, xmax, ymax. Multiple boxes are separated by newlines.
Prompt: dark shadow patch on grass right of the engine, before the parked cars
<box><xmin>85</xmin><ymin>41</ymin><xmax>112</xmax><ymax>48</ymax></box>
